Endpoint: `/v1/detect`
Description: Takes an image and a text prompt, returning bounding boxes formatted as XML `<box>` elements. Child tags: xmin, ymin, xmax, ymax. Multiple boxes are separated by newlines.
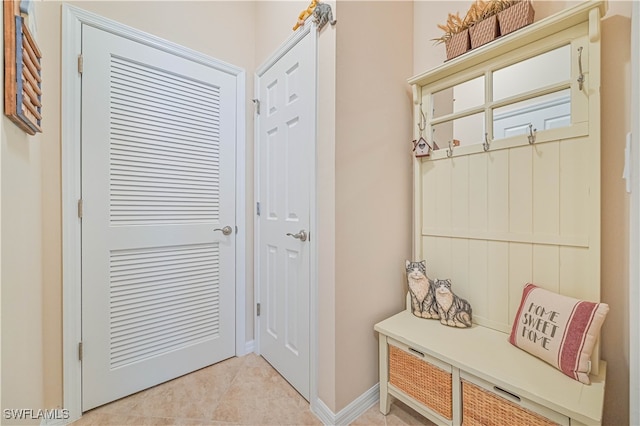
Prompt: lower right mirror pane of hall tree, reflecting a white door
<box><xmin>493</xmin><ymin>89</ymin><xmax>571</xmax><ymax>139</ymax></box>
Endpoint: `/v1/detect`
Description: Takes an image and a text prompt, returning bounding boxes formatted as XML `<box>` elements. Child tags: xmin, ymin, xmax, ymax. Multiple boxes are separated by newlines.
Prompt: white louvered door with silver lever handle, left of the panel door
<box><xmin>82</xmin><ymin>26</ymin><xmax>236</xmax><ymax>410</ymax></box>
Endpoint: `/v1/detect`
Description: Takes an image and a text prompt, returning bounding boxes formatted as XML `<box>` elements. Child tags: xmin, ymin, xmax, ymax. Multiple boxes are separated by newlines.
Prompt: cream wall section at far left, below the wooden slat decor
<box><xmin>0</xmin><ymin>0</ymin><xmax>45</xmax><ymax>421</ymax></box>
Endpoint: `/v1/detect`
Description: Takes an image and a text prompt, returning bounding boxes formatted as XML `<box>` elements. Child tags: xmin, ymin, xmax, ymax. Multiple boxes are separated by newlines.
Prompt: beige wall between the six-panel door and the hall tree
<box><xmin>332</xmin><ymin>1</ymin><xmax>413</xmax><ymax>412</ymax></box>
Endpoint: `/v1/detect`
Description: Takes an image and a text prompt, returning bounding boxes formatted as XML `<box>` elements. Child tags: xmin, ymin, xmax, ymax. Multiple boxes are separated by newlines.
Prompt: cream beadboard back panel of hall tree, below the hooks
<box><xmin>420</xmin><ymin>133</ymin><xmax>599</xmax><ymax>332</ymax></box>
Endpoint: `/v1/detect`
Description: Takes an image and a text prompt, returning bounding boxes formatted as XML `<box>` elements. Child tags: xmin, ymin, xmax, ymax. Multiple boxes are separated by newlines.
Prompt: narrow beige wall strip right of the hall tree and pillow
<box><xmin>601</xmin><ymin>1</ymin><xmax>638</xmax><ymax>425</ymax></box>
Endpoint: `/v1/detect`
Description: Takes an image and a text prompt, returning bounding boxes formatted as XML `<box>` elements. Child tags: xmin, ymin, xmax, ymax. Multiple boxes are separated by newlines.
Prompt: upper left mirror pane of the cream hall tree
<box><xmin>431</xmin><ymin>76</ymin><xmax>484</xmax><ymax>117</ymax></box>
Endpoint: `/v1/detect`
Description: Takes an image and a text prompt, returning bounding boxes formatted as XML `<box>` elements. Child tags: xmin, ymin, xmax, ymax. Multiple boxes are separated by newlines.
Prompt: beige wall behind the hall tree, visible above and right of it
<box><xmin>413</xmin><ymin>1</ymin><xmax>631</xmax><ymax>425</ymax></box>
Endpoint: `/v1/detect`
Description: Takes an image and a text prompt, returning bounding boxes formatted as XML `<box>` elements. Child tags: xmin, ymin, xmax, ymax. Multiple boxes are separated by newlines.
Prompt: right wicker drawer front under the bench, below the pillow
<box><xmin>462</xmin><ymin>380</ymin><xmax>557</xmax><ymax>426</ymax></box>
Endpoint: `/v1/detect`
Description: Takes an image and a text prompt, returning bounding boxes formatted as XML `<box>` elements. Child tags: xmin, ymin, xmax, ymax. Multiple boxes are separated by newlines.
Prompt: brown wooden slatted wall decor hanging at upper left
<box><xmin>3</xmin><ymin>1</ymin><xmax>42</xmax><ymax>135</ymax></box>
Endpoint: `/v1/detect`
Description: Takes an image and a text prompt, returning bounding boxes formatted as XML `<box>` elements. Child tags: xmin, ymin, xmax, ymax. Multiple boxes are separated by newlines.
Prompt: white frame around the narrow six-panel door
<box><xmin>253</xmin><ymin>23</ymin><xmax>319</xmax><ymax>406</ymax></box>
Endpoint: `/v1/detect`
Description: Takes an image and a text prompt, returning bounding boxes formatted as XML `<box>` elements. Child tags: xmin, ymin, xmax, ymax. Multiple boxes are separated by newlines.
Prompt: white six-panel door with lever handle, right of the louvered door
<box><xmin>257</xmin><ymin>30</ymin><xmax>316</xmax><ymax>400</ymax></box>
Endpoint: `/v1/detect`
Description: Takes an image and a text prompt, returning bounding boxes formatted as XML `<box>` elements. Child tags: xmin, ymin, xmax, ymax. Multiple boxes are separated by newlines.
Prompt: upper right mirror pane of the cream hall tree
<box><xmin>493</xmin><ymin>44</ymin><xmax>571</xmax><ymax>101</ymax></box>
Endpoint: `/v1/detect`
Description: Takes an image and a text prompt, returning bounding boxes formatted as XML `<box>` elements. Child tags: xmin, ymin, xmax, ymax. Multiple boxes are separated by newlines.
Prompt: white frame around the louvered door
<box><xmin>61</xmin><ymin>4</ymin><xmax>248</xmax><ymax>421</ymax></box>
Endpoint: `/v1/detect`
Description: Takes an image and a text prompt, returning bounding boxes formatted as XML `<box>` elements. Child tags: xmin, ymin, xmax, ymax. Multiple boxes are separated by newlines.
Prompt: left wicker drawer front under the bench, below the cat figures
<box><xmin>389</xmin><ymin>345</ymin><xmax>453</xmax><ymax>420</ymax></box>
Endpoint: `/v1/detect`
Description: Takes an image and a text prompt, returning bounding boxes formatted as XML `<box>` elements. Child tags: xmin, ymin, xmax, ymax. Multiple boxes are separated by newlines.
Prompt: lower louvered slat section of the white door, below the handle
<box><xmin>110</xmin><ymin>246</ymin><xmax>219</xmax><ymax>368</ymax></box>
